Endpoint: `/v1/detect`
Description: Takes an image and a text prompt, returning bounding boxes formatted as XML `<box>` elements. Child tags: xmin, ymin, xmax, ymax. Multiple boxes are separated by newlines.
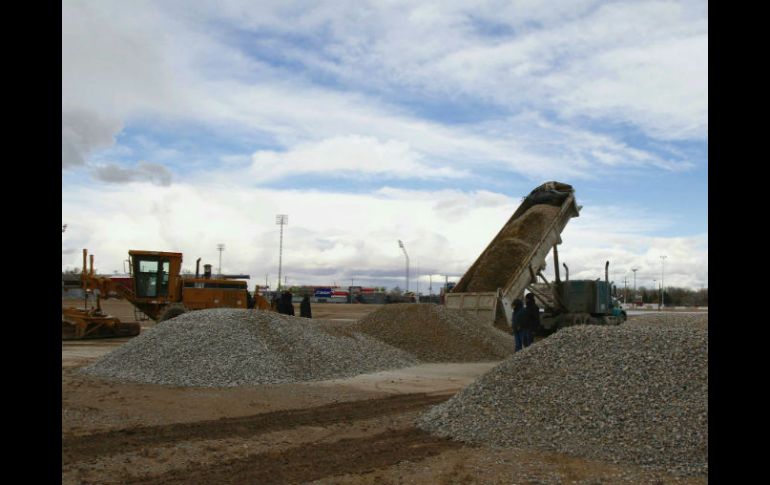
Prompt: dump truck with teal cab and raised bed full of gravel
<box><xmin>444</xmin><ymin>181</ymin><xmax>624</xmax><ymax>334</ymax></box>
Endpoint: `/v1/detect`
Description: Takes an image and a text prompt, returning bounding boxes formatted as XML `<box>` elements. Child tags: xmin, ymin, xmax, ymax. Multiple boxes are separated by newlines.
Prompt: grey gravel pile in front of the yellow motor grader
<box><xmin>82</xmin><ymin>308</ymin><xmax>419</xmax><ymax>387</ymax></box>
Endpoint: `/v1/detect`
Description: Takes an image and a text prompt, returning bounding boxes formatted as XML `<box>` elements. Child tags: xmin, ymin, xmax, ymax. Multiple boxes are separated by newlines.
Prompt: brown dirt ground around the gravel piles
<box><xmin>62</xmin><ymin>300</ymin><xmax>707</xmax><ymax>485</ymax></box>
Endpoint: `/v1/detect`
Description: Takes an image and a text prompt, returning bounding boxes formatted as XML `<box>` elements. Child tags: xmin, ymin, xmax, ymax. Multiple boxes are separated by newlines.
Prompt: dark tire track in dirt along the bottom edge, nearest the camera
<box><xmin>123</xmin><ymin>427</ymin><xmax>468</xmax><ymax>485</ymax></box>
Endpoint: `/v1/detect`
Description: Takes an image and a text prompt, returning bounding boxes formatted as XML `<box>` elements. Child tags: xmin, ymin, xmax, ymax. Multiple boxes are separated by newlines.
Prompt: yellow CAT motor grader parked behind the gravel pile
<box><xmin>62</xmin><ymin>249</ymin><xmax>249</xmax><ymax>338</ymax></box>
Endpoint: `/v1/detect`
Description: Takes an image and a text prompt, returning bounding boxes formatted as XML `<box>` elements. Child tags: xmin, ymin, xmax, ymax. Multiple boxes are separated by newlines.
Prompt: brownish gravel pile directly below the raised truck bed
<box><xmin>320</xmin><ymin>303</ymin><xmax>515</xmax><ymax>362</ymax></box>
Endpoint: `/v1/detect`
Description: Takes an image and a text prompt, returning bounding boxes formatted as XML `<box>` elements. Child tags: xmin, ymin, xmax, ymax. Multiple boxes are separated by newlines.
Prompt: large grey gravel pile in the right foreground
<box><xmin>417</xmin><ymin>315</ymin><xmax>708</xmax><ymax>475</ymax></box>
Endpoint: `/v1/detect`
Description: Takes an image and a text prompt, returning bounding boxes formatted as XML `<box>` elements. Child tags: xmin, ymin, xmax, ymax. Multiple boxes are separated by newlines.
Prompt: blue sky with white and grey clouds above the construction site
<box><xmin>62</xmin><ymin>0</ymin><xmax>708</xmax><ymax>293</ymax></box>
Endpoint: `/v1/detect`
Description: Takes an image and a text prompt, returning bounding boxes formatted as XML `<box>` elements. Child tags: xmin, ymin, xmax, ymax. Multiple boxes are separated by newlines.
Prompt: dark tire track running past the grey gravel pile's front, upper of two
<box><xmin>62</xmin><ymin>393</ymin><xmax>451</xmax><ymax>464</ymax></box>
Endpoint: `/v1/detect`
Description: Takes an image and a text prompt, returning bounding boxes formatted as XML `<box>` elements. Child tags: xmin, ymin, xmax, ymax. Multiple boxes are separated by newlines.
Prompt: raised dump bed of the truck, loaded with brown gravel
<box><xmin>445</xmin><ymin>182</ymin><xmax>580</xmax><ymax>329</ymax></box>
